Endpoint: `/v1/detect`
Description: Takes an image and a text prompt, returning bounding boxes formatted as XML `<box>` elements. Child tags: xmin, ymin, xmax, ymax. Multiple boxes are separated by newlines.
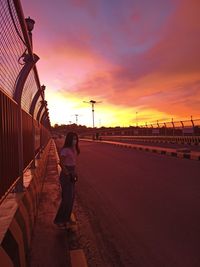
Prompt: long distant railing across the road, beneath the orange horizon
<box><xmin>80</xmin><ymin>117</ymin><xmax>200</xmax><ymax>149</ymax></box>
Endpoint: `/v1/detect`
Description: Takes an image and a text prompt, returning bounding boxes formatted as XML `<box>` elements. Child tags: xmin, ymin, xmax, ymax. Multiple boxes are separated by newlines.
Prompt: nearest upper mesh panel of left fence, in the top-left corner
<box><xmin>0</xmin><ymin>0</ymin><xmax>26</xmax><ymax>97</ymax></box>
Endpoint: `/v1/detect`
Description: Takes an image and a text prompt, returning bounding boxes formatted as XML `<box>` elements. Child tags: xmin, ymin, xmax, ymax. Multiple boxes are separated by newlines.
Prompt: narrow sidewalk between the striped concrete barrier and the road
<box><xmin>29</xmin><ymin>142</ymin><xmax>71</xmax><ymax>267</ymax></box>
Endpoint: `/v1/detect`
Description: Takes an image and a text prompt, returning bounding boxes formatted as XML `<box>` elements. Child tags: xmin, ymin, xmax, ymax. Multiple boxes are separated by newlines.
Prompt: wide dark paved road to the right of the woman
<box><xmin>74</xmin><ymin>141</ymin><xmax>200</xmax><ymax>267</ymax></box>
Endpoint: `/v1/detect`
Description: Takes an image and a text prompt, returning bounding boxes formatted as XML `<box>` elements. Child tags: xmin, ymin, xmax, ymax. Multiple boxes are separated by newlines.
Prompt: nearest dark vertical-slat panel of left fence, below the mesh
<box><xmin>0</xmin><ymin>91</ymin><xmax>19</xmax><ymax>198</ymax></box>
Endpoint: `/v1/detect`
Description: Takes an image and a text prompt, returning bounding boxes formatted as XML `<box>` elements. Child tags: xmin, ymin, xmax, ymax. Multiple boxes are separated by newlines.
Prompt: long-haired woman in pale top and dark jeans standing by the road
<box><xmin>54</xmin><ymin>132</ymin><xmax>80</xmax><ymax>227</ymax></box>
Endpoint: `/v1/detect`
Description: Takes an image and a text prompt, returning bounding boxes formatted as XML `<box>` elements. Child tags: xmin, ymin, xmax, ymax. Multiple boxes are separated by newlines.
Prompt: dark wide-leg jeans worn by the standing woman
<box><xmin>54</xmin><ymin>171</ymin><xmax>75</xmax><ymax>223</ymax></box>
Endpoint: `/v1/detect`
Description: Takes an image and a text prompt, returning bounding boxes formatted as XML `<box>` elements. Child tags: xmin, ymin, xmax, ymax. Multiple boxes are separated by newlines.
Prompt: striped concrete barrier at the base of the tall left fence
<box><xmin>0</xmin><ymin>141</ymin><xmax>52</xmax><ymax>267</ymax></box>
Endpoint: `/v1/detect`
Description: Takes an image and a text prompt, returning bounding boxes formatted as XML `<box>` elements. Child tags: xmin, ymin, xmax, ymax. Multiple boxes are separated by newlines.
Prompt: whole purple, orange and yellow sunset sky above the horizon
<box><xmin>21</xmin><ymin>0</ymin><xmax>200</xmax><ymax>127</ymax></box>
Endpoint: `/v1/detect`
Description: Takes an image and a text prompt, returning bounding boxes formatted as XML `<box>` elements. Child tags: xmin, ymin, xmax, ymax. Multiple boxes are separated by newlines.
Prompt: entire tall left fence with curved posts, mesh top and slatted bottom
<box><xmin>0</xmin><ymin>0</ymin><xmax>50</xmax><ymax>202</ymax></box>
